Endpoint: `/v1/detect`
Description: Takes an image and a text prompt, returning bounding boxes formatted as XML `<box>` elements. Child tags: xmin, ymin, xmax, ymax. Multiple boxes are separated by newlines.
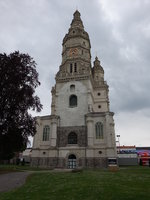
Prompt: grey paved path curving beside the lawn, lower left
<box><xmin>0</xmin><ymin>172</ymin><xmax>31</xmax><ymax>192</ymax></box>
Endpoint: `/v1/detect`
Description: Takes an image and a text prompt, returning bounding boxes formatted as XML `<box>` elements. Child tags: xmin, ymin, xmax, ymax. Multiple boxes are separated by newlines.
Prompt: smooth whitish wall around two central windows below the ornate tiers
<box><xmin>56</xmin><ymin>81</ymin><xmax>88</xmax><ymax>126</ymax></box>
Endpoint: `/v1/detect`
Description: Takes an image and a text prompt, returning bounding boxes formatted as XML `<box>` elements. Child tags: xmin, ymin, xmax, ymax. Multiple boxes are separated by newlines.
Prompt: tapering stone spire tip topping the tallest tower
<box><xmin>71</xmin><ymin>10</ymin><xmax>84</xmax><ymax>29</ymax></box>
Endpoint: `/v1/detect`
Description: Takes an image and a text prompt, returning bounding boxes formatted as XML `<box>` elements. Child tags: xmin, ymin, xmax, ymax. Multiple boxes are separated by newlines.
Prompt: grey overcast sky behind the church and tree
<box><xmin>0</xmin><ymin>0</ymin><xmax>150</xmax><ymax>146</ymax></box>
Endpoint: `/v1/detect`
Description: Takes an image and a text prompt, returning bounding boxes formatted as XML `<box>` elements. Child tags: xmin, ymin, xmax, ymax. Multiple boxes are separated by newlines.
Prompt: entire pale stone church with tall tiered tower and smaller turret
<box><xmin>32</xmin><ymin>11</ymin><xmax>117</xmax><ymax>168</ymax></box>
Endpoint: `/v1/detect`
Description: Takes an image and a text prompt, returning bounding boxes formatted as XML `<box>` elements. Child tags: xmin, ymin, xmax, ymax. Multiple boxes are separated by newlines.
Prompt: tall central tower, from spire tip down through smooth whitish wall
<box><xmin>51</xmin><ymin>10</ymin><xmax>93</xmax><ymax>127</ymax></box>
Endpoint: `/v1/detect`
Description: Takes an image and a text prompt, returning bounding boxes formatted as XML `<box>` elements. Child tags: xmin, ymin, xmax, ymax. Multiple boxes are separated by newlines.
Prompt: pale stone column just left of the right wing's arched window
<box><xmin>87</xmin><ymin>117</ymin><xmax>93</xmax><ymax>146</ymax></box>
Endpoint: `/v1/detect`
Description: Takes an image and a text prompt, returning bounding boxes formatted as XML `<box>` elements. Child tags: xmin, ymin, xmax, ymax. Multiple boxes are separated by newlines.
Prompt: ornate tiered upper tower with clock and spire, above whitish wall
<box><xmin>56</xmin><ymin>10</ymin><xmax>91</xmax><ymax>82</ymax></box>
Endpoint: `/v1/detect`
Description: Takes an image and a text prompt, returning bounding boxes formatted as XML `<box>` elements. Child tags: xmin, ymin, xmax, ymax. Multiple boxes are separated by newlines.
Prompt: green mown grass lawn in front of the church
<box><xmin>0</xmin><ymin>167</ymin><xmax>150</xmax><ymax>200</ymax></box>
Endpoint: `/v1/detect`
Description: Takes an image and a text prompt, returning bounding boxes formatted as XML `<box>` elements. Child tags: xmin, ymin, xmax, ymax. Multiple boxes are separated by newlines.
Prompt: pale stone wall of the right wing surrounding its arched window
<box><xmin>86</xmin><ymin>112</ymin><xmax>116</xmax><ymax>157</ymax></box>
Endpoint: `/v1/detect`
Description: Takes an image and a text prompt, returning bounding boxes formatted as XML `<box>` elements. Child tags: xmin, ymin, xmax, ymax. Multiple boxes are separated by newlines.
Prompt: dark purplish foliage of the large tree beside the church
<box><xmin>0</xmin><ymin>51</ymin><xmax>42</xmax><ymax>159</ymax></box>
